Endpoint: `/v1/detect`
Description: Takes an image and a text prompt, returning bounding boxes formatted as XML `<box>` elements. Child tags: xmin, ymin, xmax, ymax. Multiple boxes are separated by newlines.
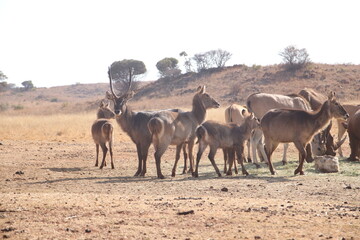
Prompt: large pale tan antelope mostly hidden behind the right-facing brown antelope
<box><xmin>246</xmin><ymin>93</ymin><xmax>311</xmax><ymax>165</ymax></box>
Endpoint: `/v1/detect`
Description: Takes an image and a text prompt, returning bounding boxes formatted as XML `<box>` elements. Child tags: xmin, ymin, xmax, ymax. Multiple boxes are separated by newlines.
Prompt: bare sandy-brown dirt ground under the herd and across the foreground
<box><xmin>0</xmin><ymin>140</ymin><xmax>360</xmax><ymax>239</ymax></box>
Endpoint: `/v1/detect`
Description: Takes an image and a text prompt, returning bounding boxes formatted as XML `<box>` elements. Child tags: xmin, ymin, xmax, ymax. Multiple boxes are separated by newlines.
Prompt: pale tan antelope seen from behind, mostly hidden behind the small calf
<box><xmin>223</xmin><ymin>104</ymin><xmax>251</xmax><ymax>174</ymax></box>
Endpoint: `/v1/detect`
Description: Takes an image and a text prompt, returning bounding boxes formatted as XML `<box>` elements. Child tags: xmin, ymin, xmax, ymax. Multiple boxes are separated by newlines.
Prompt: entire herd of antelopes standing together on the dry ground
<box><xmin>91</xmin><ymin>67</ymin><xmax>360</xmax><ymax>179</ymax></box>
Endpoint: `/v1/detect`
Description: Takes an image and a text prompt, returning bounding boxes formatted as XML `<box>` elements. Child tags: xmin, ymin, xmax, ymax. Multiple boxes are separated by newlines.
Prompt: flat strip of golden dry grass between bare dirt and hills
<box><xmin>0</xmin><ymin>108</ymin><xmax>228</xmax><ymax>142</ymax></box>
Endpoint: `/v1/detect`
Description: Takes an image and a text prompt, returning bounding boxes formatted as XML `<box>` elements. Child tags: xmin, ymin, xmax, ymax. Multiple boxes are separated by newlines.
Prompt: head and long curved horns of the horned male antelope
<box><xmin>106</xmin><ymin>67</ymin><xmax>134</xmax><ymax>116</ymax></box>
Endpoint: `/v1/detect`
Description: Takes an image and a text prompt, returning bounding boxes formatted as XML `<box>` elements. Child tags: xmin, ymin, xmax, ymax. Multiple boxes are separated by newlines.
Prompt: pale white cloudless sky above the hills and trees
<box><xmin>0</xmin><ymin>0</ymin><xmax>360</xmax><ymax>87</ymax></box>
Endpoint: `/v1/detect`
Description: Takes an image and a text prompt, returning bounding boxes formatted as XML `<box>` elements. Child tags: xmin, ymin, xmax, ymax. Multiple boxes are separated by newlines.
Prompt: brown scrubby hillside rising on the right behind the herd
<box><xmin>135</xmin><ymin>64</ymin><xmax>360</xmax><ymax>108</ymax></box>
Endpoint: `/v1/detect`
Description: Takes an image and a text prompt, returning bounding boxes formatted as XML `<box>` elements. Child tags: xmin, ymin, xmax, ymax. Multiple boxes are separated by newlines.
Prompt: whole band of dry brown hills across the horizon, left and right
<box><xmin>0</xmin><ymin>64</ymin><xmax>360</xmax><ymax>115</ymax></box>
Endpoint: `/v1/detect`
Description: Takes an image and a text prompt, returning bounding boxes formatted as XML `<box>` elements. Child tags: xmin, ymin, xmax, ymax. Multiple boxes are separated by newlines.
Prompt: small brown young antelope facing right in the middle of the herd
<box><xmin>193</xmin><ymin>114</ymin><xmax>259</xmax><ymax>177</ymax></box>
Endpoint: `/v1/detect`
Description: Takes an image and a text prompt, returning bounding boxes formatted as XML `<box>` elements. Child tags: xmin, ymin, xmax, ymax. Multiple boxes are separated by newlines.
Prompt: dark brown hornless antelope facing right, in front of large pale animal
<box><xmin>261</xmin><ymin>92</ymin><xmax>349</xmax><ymax>175</ymax></box>
